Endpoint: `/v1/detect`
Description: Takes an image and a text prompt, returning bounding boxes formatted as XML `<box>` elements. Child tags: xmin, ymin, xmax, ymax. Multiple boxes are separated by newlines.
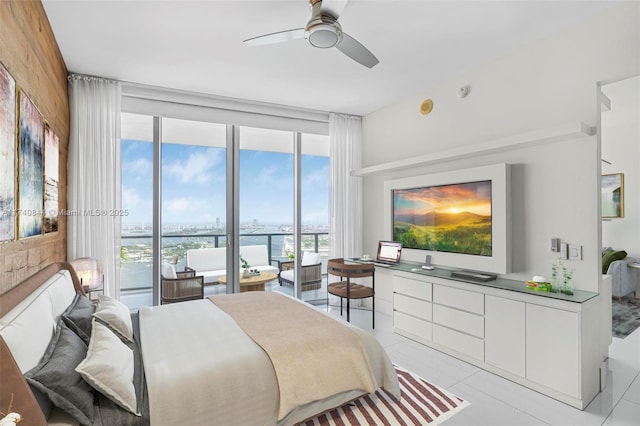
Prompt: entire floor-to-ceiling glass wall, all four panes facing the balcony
<box><xmin>121</xmin><ymin>113</ymin><xmax>329</xmax><ymax>308</ymax></box>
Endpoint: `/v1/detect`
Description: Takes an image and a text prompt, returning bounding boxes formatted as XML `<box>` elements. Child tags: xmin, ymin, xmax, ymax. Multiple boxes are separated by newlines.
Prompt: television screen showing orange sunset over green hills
<box><xmin>393</xmin><ymin>180</ymin><xmax>491</xmax><ymax>256</ymax></box>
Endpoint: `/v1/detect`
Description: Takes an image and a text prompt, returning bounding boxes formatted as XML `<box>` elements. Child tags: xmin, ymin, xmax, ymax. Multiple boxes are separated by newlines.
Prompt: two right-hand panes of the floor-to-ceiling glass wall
<box><xmin>239</xmin><ymin>127</ymin><xmax>329</xmax><ymax>303</ymax></box>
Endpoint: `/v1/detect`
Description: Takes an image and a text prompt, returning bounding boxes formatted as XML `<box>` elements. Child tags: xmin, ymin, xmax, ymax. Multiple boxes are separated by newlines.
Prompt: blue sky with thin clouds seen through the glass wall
<box><xmin>121</xmin><ymin>139</ymin><xmax>329</xmax><ymax>226</ymax></box>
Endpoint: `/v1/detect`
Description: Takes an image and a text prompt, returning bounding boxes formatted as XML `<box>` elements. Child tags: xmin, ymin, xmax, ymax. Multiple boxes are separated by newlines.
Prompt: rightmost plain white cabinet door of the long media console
<box><xmin>526</xmin><ymin>303</ymin><xmax>580</xmax><ymax>398</ymax></box>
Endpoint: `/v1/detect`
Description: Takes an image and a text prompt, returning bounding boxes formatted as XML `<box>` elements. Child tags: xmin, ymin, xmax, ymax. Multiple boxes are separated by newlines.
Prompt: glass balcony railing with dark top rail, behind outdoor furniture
<box><xmin>120</xmin><ymin>232</ymin><xmax>329</xmax><ymax>292</ymax></box>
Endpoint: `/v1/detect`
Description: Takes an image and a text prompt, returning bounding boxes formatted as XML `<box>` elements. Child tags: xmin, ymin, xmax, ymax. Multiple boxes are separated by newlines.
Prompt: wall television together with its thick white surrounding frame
<box><xmin>381</xmin><ymin>164</ymin><xmax>511</xmax><ymax>274</ymax></box>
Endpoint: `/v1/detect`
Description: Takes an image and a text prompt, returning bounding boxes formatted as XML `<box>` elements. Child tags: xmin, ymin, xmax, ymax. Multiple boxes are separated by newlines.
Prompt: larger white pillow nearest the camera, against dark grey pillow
<box><xmin>75</xmin><ymin>321</ymin><xmax>140</xmax><ymax>416</ymax></box>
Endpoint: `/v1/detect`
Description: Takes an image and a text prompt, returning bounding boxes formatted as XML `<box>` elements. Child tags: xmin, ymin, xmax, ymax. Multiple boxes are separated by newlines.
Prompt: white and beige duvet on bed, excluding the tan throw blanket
<box><xmin>139</xmin><ymin>300</ymin><xmax>400</xmax><ymax>426</ymax></box>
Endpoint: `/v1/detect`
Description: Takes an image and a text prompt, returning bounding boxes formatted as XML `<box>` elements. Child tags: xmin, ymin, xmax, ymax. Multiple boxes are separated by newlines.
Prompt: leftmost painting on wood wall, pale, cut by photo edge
<box><xmin>0</xmin><ymin>64</ymin><xmax>16</xmax><ymax>241</ymax></box>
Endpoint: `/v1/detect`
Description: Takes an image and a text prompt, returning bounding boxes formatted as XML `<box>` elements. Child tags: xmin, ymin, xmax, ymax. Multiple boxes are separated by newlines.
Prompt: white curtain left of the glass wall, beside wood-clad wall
<box><xmin>67</xmin><ymin>75</ymin><xmax>122</xmax><ymax>297</ymax></box>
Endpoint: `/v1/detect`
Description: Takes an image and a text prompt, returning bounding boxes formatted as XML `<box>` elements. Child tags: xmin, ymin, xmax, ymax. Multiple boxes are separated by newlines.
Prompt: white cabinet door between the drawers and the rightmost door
<box><xmin>484</xmin><ymin>295</ymin><xmax>526</xmax><ymax>377</ymax></box>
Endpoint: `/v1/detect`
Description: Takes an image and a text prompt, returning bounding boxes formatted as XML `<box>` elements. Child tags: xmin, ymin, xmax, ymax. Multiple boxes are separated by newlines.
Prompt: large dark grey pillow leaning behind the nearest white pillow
<box><xmin>25</xmin><ymin>320</ymin><xmax>93</xmax><ymax>425</ymax></box>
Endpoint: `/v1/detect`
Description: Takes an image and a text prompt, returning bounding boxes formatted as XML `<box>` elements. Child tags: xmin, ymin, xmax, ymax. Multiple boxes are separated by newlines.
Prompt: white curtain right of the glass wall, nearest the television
<box><xmin>329</xmin><ymin>113</ymin><xmax>362</xmax><ymax>257</ymax></box>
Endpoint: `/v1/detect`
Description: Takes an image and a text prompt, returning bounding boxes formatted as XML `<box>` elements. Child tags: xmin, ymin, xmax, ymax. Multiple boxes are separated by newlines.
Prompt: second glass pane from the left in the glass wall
<box><xmin>160</xmin><ymin>118</ymin><xmax>227</xmax><ymax>295</ymax></box>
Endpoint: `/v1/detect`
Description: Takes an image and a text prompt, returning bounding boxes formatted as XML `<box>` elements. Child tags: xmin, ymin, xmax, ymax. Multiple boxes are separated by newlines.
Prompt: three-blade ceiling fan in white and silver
<box><xmin>244</xmin><ymin>0</ymin><xmax>379</xmax><ymax>68</ymax></box>
